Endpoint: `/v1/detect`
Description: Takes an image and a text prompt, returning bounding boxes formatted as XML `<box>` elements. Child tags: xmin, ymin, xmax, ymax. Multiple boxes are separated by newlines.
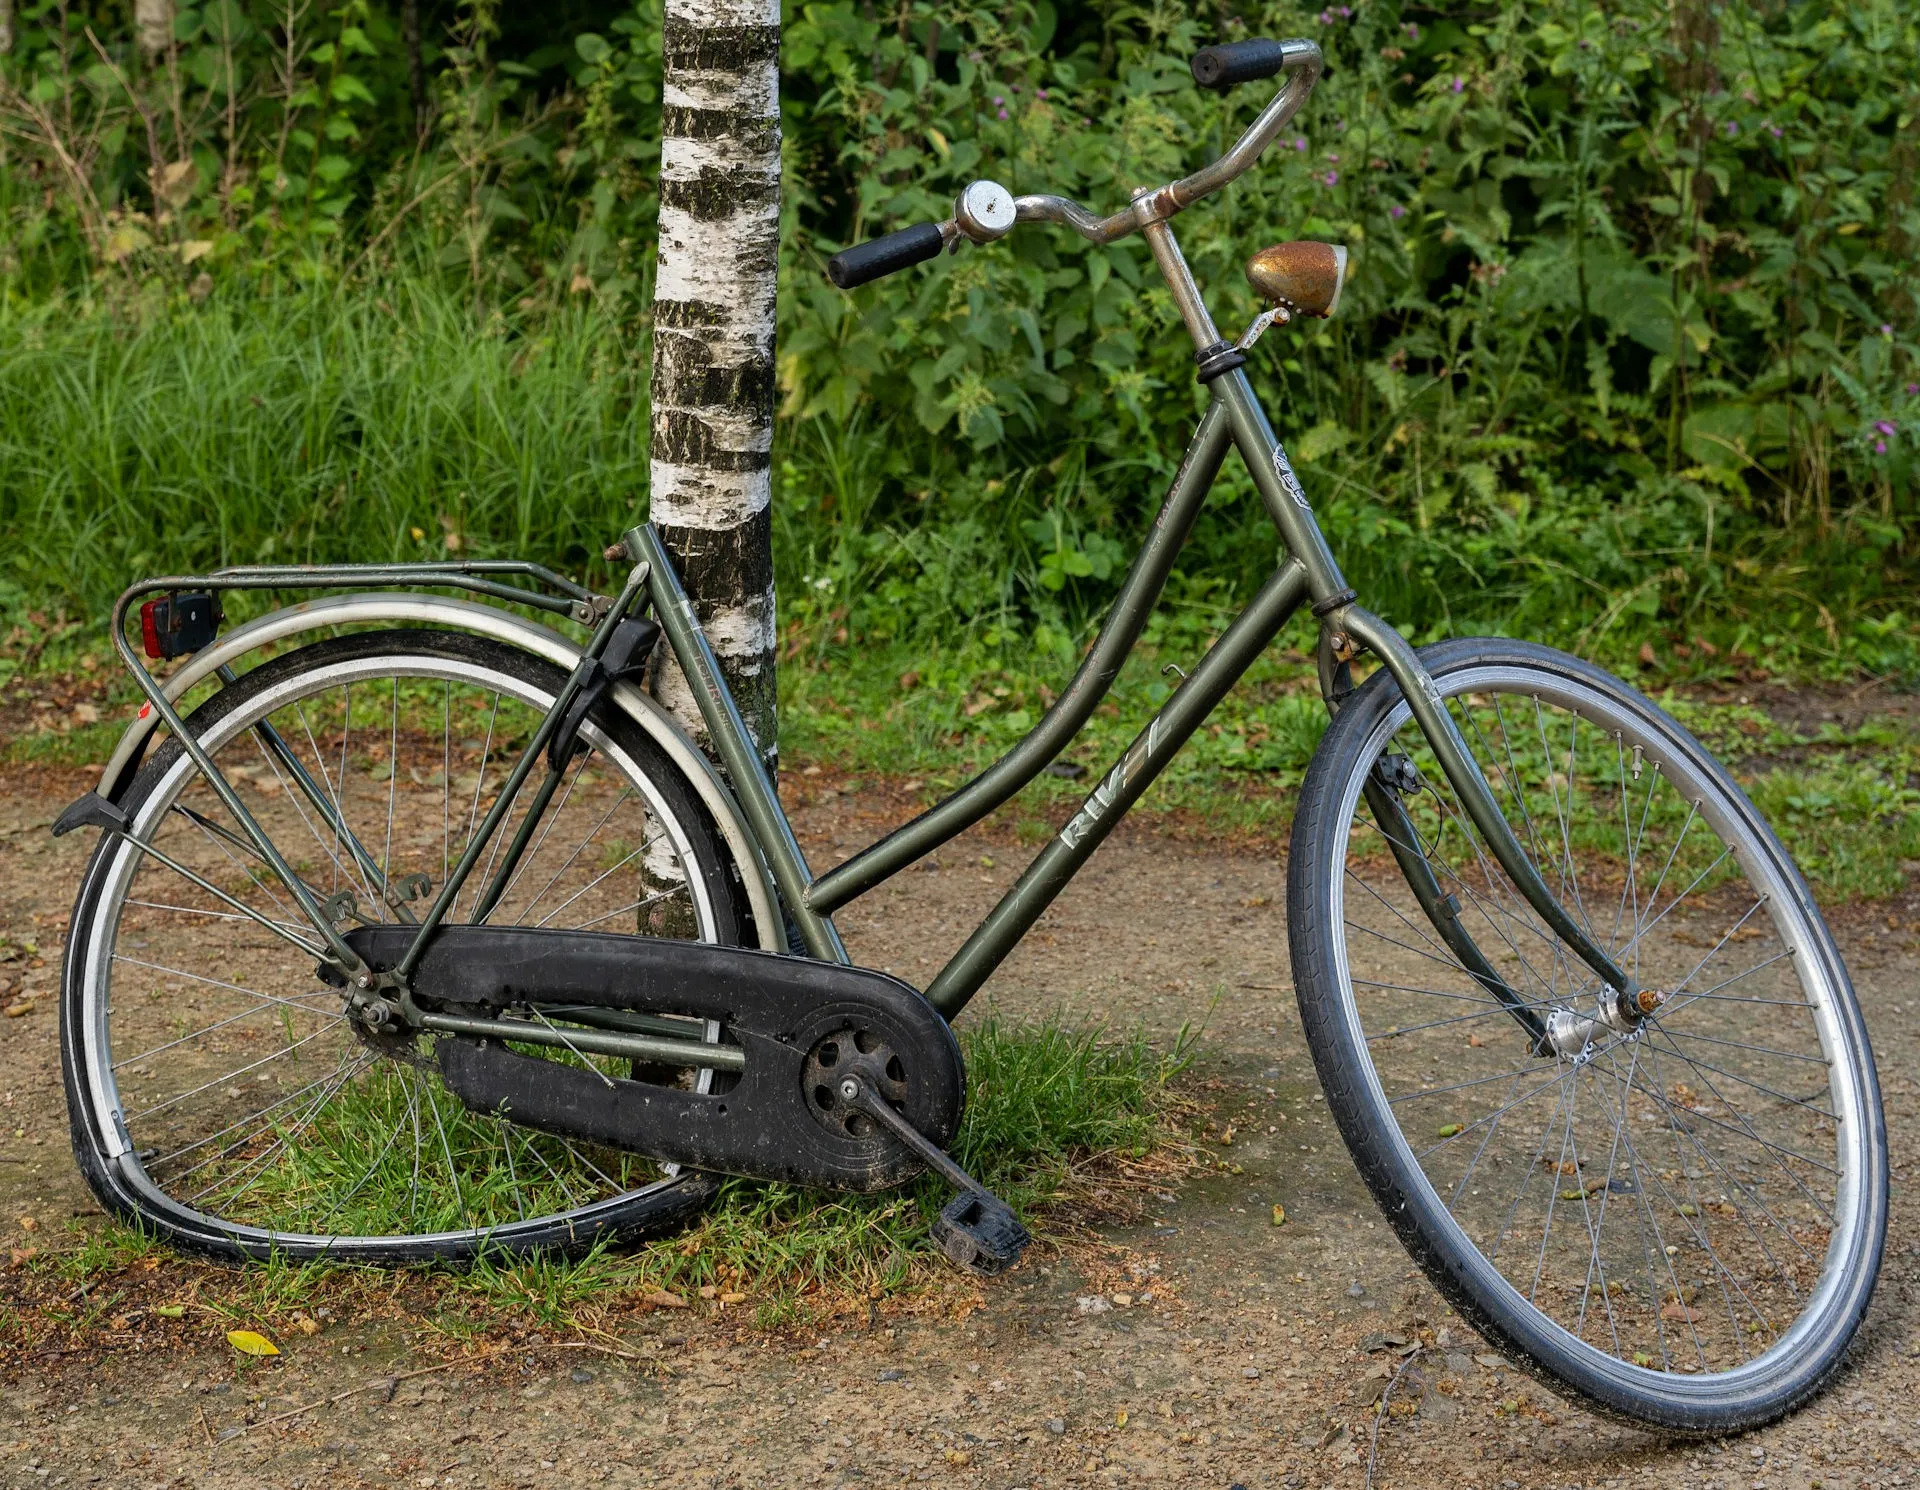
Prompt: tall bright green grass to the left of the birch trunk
<box><xmin>0</xmin><ymin>278</ymin><xmax>647</xmax><ymax>613</ymax></box>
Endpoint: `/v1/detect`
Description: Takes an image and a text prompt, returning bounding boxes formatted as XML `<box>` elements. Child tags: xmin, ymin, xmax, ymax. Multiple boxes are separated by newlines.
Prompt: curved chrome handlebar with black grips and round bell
<box><xmin>828</xmin><ymin>36</ymin><xmax>1323</xmax><ymax>290</ymax></box>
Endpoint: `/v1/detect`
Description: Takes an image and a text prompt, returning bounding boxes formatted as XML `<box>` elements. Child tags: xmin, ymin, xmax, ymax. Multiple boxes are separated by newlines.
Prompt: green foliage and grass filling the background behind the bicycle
<box><xmin>0</xmin><ymin>0</ymin><xmax>1920</xmax><ymax>672</ymax></box>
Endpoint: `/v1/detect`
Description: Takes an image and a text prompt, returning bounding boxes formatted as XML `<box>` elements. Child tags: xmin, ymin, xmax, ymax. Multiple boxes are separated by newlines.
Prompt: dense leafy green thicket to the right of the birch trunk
<box><xmin>781</xmin><ymin>0</ymin><xmax>1920</xmax><ymax>641</ymax></box>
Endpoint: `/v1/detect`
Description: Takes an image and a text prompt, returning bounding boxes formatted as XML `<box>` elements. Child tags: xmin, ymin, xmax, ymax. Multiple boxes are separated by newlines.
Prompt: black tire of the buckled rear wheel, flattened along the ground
<box><xmin>60</xmin><ymin>630</ymin><xmax>749</xmax><ymax>1265</ymax></box>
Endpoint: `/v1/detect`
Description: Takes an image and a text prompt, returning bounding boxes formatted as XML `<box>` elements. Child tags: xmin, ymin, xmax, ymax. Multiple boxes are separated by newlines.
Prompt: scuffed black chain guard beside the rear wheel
<box><xmin>346</xmin><ymin>925</ymin><xmax>966</xmax><ymax>1190</ymax></box>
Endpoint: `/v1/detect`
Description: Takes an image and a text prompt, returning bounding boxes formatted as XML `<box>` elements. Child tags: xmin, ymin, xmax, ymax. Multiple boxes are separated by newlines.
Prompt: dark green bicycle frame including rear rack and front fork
<box><xmin>101</xmin><ymin>221</ymin><xmax>1638</xmax><ymax>1064</ymax></box>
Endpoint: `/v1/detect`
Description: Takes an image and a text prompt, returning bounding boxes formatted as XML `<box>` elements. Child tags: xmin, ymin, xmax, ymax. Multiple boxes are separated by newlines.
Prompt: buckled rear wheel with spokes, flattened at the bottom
<box><xmin>61</xmin><ymin>630</ymin><xmax>743</xmax><ymax>1263</ymax></box>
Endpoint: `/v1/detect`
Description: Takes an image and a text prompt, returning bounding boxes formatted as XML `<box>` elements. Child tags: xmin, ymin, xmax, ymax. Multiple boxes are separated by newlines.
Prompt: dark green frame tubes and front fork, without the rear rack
<box><xmin>622</xmin><ymin>223</ymin><xmax>1636</xmax><ymax>1020</ymax></box>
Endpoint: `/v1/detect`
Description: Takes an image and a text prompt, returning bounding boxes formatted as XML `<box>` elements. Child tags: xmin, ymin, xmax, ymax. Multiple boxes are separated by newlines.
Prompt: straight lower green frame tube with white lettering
<box><xmin>927</xmin><ymin>559</ymin><xmax>1308</xmax><ymax>1020</ymax></box>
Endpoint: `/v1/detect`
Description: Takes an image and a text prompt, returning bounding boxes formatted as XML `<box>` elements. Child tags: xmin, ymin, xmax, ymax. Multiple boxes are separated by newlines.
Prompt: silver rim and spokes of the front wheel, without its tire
<box><xmin>1327</xmin><ymin>664</ymin><xmax>1870</xmax><ymax>1392</ymax></box>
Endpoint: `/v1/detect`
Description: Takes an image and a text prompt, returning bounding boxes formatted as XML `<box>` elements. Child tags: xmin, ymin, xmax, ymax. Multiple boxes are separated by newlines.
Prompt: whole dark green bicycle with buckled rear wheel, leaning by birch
<box><xmin>54</xmin><ymin>40</ymin><xmax>1887</xmax><ymax>1432</ymax></box>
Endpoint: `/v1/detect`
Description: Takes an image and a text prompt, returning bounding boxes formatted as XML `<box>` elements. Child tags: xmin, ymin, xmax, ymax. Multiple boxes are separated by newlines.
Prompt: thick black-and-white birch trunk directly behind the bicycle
<box><xmin>649</xmin><ymin>0</ymin><xmax>780</xmax><ymax>768</ymax></box>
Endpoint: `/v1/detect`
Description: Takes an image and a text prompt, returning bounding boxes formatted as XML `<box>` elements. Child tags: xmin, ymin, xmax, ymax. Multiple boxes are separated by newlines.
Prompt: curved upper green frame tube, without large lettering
<box><xmin>806</xmin><ymin>397</ymin><xmax>1233</xmax><ymax>914</ymax></box>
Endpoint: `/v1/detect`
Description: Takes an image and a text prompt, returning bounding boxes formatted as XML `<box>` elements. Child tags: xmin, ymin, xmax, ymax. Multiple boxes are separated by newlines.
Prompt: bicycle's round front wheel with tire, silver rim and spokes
<box><xmin>1288</xmin><ymin>639</ymin><xmax>1887</xmax><ymax>1432</ymax></box>
